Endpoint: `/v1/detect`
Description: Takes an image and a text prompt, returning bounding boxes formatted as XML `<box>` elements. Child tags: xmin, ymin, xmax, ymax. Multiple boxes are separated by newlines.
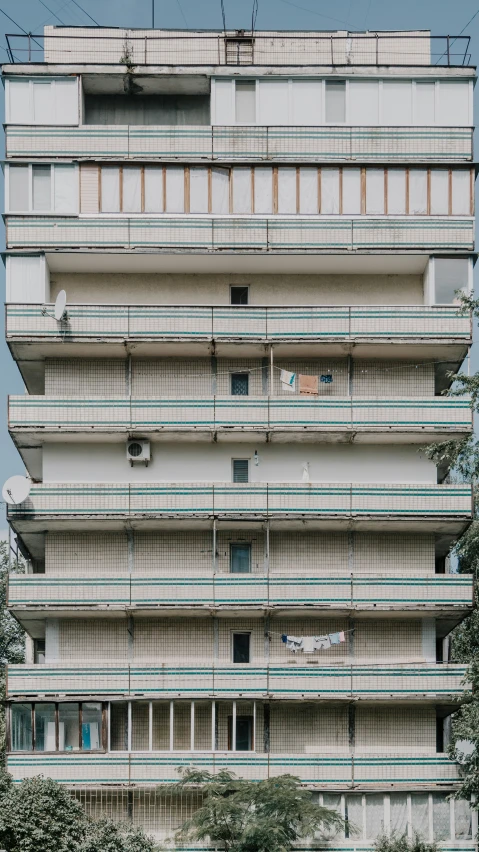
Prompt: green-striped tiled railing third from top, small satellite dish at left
<box><xmin>6</xmin><ymin>304</ymin><xmax>472</xmax><ymax>344</ymax></box>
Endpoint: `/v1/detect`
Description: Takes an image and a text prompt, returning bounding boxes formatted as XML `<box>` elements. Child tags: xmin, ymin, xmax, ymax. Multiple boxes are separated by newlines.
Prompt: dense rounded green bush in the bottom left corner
<box><xmin>0</xmin><ymin>772</ymin><xmax>155</xmax><ymax>852</ymax></box>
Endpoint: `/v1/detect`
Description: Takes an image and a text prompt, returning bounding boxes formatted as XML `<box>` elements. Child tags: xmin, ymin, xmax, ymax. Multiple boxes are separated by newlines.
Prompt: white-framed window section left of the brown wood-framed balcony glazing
<box><xmin>7</xmin><ymin>164</ymin><xmax>78</xmax><ymax>215</ymax></box>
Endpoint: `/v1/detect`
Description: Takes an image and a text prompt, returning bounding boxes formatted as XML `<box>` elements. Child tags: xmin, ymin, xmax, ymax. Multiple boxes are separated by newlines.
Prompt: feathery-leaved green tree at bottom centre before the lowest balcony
<box><xmin>170</xmin><ymin>769</ymin><xmax>344</xmax><ymax>852</ymax></box>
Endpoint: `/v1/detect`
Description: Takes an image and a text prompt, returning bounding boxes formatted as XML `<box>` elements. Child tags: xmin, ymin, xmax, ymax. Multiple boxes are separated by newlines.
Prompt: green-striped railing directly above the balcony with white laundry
<box><xmin>8</xmin><ymin>570</ymin><xmax>472</xmax><ymax>613</ymax></box>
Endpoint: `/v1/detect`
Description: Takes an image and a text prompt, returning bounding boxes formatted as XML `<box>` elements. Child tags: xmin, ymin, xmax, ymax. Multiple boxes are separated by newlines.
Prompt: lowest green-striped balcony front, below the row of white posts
<box><xmin>2</xmin><ymin>751</ymin><xmax>460</xmax><ymax>789</ymax></box>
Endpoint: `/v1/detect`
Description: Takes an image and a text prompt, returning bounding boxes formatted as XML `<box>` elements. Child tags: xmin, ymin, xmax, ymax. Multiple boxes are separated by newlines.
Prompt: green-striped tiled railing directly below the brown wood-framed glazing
<box><xmin>6</xmin><ymin>214</ymin><xmax>474</xmax><ymax>254</ymax></box>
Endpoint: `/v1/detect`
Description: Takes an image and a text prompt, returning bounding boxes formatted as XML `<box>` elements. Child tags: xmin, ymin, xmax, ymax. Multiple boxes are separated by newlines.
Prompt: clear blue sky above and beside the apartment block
<box><xmin>0</xmin><ymin>0</ymin><xmax>479</xmax><ymax>532</ymax></box>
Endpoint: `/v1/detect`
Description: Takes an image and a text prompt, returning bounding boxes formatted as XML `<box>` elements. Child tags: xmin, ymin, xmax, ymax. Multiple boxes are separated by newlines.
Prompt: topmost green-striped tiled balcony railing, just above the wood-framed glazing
<box><xmin>5</xmin><ymin>125</ymin><xmax>473</xmax><ymax>164</ymax></box>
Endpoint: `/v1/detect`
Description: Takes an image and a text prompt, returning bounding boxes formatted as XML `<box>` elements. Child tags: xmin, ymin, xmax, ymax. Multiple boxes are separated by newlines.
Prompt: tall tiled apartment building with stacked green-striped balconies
<box><xmin>3</xmin><ymin>27</ymin><xmax>477</xmax><ymax>850</ymax></box>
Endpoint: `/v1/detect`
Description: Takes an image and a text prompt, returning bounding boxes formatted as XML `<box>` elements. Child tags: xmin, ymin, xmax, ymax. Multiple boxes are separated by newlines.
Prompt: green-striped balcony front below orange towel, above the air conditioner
<box><xmin>8</xmin><ymin>395</ymin><xmax>472</xmax><ymax>446</ymax></box>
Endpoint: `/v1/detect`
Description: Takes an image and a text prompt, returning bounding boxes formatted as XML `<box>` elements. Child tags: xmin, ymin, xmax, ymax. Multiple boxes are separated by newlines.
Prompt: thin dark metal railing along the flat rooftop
<box><xmin>5</xmin><ymin>28</ymin><xmax>471</xmax><ymax>68</ymax></box>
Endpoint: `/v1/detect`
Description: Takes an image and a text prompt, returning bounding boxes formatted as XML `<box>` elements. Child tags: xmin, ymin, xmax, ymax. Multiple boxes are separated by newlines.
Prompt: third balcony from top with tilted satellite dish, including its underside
<box><xmin>5</xmin><ymin>304</ymin><xmax>472</xmax><ymax>372</ymax></box>
